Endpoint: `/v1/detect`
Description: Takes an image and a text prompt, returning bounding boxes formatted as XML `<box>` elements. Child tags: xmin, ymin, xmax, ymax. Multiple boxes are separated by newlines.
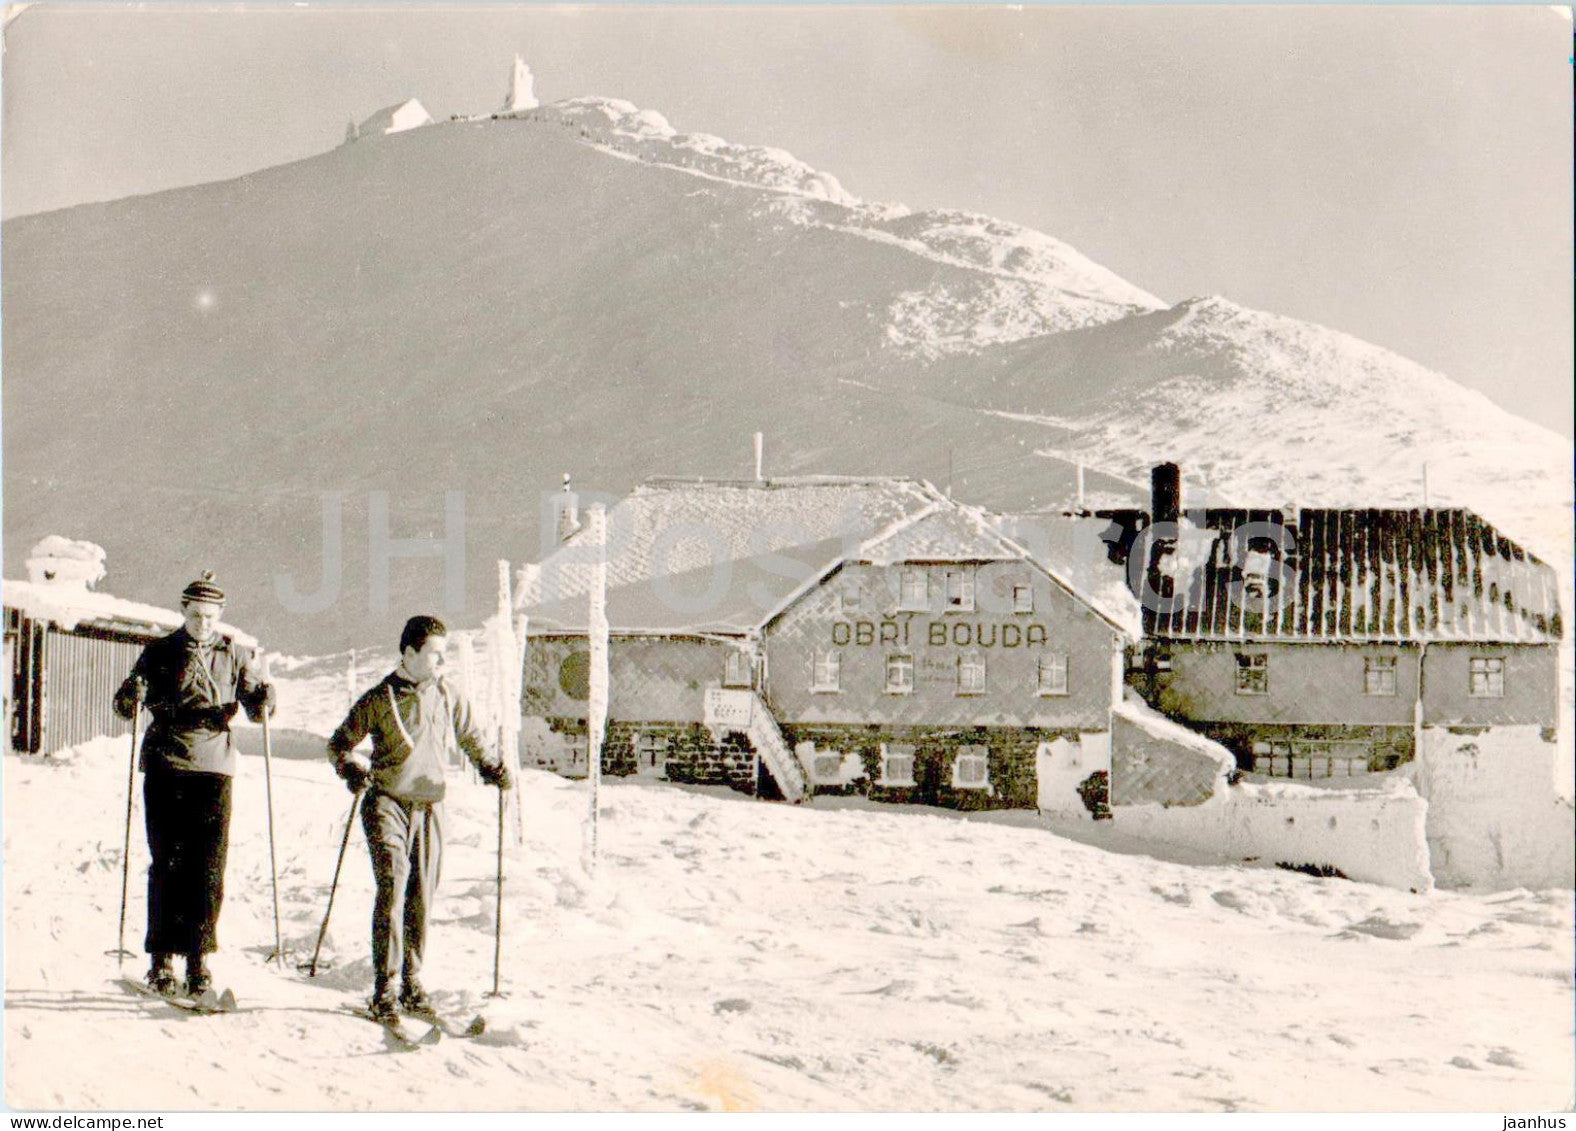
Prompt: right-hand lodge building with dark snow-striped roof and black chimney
<box><xmin>1105</xmin><ymin>465</ymin><xmax>1562</xmax><ymax>778</ymax></box>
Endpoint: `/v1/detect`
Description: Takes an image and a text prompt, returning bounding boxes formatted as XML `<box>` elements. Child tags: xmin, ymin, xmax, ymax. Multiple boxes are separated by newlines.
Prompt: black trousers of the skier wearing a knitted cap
<box><xmin>142</xmin><ymin>767</ymin><xmax>230</xmax><ymax>955</ymax></box>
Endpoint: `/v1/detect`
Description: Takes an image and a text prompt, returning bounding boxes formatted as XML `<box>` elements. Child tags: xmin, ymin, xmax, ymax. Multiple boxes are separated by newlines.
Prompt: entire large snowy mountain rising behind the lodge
<box><xmin>3</xmin><ymin>99</ymin><xmax>1571</xmax><ymax>652</ymax></box>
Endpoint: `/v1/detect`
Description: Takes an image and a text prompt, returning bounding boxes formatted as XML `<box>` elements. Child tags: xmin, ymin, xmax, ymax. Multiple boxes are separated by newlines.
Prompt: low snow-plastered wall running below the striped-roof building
<box><xmin>1114</xmin><ymin>777</ymin><xmax>1434</xmax><ymax>892</ymax></box>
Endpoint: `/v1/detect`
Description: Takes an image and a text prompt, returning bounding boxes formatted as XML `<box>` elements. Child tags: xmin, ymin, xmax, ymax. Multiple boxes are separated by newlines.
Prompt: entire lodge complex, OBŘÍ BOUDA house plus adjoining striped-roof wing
<box><xmin>522</xmin><ymin>465</ymin><xmax>1562</xmax><ymax>810</ymax></box>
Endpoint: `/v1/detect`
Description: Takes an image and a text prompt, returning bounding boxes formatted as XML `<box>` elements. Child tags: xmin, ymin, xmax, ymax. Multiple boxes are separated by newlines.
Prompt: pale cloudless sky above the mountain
<box><xmin>0</xmin><ymin>3</ymin><xmax>1573</xmax><ymax>435</ymax></box>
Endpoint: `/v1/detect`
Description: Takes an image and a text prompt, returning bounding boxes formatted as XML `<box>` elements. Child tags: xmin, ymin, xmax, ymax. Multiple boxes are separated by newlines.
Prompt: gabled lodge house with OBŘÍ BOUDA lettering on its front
<box><xmin>522</xmin><ymin>477</ymin><xmax>1138</xmax><ymax>808</ymax></box>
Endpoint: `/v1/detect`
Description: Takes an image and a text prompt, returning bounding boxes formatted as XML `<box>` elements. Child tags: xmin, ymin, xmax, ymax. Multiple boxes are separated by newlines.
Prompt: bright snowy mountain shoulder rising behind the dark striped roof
<box><xmin>901</xmin><ymin>296</ymin><xmax>1571</xmax><ymax>566</ymax></box>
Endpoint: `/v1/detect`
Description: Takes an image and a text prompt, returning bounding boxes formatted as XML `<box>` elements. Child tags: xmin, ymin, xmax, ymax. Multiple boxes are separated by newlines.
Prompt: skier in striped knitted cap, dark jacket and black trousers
<box><xmin>115</xmin><ymin>573</ymin><xmax>274</xmax><ymax>994</ymax></box>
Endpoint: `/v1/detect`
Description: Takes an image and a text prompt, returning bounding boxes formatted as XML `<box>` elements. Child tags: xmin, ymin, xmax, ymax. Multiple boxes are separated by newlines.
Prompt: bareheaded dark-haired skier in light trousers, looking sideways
<box><xmin>328</xmin><ymin>616</ymin><xmax>511</xmax><ymax>1021</ymax></box>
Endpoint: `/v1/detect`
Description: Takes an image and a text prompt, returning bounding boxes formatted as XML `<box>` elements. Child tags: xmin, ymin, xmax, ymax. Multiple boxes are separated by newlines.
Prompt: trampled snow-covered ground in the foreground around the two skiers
<box><xmin>5</xmin><ymin>739</ymin><xmax>1573</xmax><ymax>1111</ymax></box>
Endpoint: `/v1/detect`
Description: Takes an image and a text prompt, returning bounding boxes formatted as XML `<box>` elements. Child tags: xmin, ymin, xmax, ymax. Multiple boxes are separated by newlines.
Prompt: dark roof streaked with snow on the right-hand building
<box><xmin>1144</xmin><ymin>509</ymin><xmax>1562</xmax><ymax>643</ymax></box>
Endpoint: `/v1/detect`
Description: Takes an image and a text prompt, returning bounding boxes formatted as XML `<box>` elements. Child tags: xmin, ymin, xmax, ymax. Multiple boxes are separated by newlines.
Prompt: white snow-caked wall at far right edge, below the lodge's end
<box><xmin>1412</xmin><ymin>726</ymin><xmax>1576</xmax><ymax>888</ymax></box>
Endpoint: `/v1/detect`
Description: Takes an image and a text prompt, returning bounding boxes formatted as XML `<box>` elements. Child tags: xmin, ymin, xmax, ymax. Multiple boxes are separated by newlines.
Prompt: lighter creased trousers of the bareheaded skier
<box><xmin>361</xmin><ymin>789</ymin><xmax>443</xmax><ymax>986</ymax></box>
